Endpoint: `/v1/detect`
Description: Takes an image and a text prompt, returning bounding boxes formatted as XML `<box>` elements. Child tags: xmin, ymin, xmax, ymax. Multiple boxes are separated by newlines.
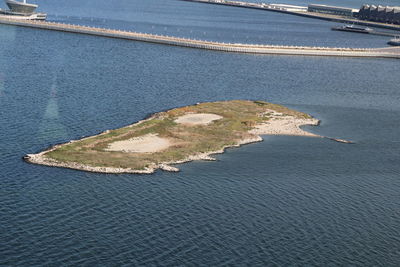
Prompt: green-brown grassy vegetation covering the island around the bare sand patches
<box><xmin>36</xmin><ymin>100</ymin><xmax>310</xmax><ymax>170</ymax></box>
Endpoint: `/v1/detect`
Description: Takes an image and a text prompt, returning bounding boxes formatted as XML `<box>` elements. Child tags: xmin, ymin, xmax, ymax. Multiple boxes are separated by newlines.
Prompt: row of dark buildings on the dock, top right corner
<box><xmin>358</xmin><ymin>5</ymin><xmax>400</xmax><ymax>25</ymax></box>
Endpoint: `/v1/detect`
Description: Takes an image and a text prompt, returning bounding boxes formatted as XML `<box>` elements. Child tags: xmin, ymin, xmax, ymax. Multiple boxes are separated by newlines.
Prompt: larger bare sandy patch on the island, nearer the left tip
<box><xmin>106</xmin><ymin>134</ymin><xmax>171</xmax><ymax>153</ymax></box>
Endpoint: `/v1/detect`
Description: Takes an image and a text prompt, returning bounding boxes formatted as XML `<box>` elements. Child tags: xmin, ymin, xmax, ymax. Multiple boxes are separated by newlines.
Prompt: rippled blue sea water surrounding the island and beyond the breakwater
<box><xmin>0</xmin><ymin>0</ymin><xmax>400</xmax><ymax>266</ymax></box>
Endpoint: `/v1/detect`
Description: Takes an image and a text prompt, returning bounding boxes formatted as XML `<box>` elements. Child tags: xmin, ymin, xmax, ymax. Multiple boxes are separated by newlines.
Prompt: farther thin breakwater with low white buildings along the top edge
<box><xmin>181</xmin><ymin>0</ymin><xmax>400</xmax><ymax>31</ymax></box>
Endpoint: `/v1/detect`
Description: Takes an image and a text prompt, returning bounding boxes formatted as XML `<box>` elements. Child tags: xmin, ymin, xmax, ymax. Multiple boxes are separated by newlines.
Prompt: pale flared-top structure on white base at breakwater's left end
<box><xmin>0</xmin><ymin>0</ymin><xmax>47</xmax><ymax>20</ymax></box>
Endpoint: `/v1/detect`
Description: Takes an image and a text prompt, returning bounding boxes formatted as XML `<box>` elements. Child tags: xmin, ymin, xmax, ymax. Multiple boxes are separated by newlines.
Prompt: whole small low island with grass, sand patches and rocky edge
<box><xmin>24</xmin><ymin>100</ymin><xmax>320</xmax><ymax>174</ymax></box>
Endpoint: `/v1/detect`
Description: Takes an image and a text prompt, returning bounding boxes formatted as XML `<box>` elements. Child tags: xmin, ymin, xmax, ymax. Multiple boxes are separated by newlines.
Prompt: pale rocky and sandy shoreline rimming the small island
<box><xmin>23</xmin><ymin>100</ymin><xmax>352</xmax><ymax>174</ymax></box>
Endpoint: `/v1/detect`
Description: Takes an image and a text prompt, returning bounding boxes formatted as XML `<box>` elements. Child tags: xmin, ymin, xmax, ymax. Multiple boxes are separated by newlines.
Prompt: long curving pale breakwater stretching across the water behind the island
<box><xmin>0</xmin><ymin>19</ymin><xmax>400</xmax><ymax>59</ymax></box>
